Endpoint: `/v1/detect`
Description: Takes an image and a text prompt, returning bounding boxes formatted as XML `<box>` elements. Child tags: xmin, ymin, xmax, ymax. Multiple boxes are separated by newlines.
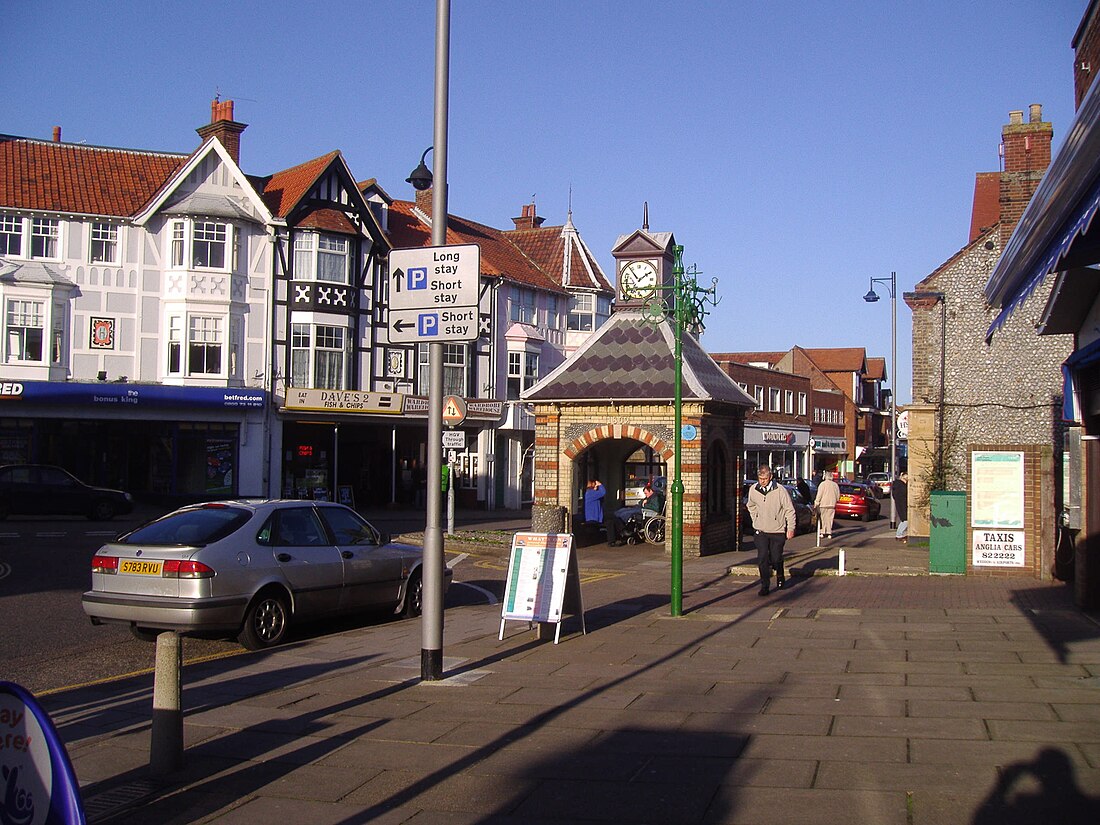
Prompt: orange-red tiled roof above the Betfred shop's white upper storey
<box><xmin>0</xmin><ymin>135</ymin><xmax>190</xmax><ymax>217</ymax></box>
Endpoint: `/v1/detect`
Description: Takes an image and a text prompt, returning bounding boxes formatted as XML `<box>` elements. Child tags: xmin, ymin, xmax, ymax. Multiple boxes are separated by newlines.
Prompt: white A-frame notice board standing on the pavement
<box><xmin>499</xmin><ymin>532</ymin><xmax>587</xmax><ymax>645</ymax></box>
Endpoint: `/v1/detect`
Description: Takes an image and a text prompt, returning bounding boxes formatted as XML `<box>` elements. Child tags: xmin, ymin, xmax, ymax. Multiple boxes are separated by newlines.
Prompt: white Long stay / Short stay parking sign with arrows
<box><xmin>387</xmin><ymin>243</ymin><xmax>481</xmax><ymax>343</ymax></box>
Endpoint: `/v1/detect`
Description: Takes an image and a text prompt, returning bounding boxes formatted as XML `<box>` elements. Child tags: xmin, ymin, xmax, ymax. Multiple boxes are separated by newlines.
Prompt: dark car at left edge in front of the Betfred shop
<box><xmin>0</xmin><ymin>464</ymin><xmax>134</xmax><ymax>521</ymax></box>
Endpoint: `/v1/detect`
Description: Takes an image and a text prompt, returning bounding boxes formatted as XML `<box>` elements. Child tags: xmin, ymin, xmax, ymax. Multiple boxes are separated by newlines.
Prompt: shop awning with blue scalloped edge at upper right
<box><xmin>985</xmin><ymin>84</ymin><xmax>1100</xmax><ymax>341</ymax></box>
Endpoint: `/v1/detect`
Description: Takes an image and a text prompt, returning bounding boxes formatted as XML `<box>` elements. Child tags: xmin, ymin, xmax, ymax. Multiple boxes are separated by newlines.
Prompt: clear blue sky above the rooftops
<box><xmin>0</xmin><ymin>0</ymin><xmax>1087</xmax><ymax>403</ymax></box>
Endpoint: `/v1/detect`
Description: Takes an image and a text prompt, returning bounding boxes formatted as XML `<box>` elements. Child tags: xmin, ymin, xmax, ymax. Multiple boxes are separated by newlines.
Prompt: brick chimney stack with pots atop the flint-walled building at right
<box><xmin>1000</xmin><ymin>103</ymin><xmax>1054</xmax><ymax>243</ymax></box>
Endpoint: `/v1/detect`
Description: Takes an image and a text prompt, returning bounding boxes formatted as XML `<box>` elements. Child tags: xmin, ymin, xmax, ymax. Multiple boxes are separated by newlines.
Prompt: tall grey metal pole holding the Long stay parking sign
<box><xmin>420</xmin><ymin>0</ymin><xmax>451</xmax><ymax>682</ymax></box>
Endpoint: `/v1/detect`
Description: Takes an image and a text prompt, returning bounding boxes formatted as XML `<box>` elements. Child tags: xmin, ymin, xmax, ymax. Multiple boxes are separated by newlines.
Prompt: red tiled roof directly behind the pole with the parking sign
<box><xmin>389</xmin><ymin>200</ymin><xmax>563</xmax><ymax>293</ymax></box>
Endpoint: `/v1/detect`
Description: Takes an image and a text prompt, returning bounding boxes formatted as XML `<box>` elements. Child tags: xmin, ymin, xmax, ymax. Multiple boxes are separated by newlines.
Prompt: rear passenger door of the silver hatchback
<box><xmin>271</xmin><ymin>505</ymin><xmax>344</xmax><ymax>616</ymax></box>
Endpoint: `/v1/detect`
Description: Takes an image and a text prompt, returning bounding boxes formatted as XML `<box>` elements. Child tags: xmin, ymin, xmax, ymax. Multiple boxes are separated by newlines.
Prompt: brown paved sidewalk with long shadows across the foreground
<box><xmin>44</xmin><ymin>539</ymin><xmax>1100</xmax><ymax>825</ymax></box>
